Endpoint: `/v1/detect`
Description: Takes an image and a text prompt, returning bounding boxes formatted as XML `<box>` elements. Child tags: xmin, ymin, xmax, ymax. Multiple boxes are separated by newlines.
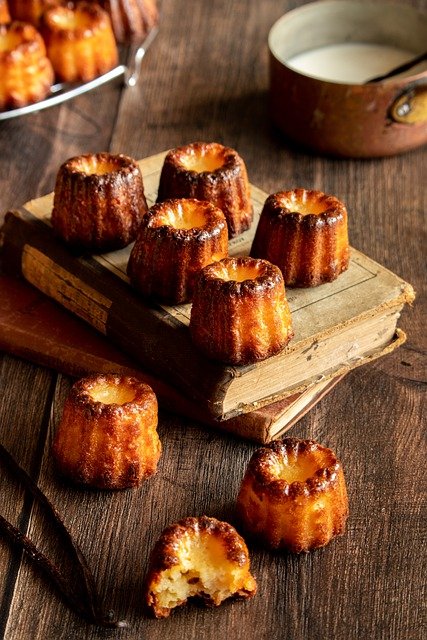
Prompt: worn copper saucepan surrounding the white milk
<box><xmin>268</xmin><ymin>0</ymin><xmax>427</xmax><ymax>157</ymax></box>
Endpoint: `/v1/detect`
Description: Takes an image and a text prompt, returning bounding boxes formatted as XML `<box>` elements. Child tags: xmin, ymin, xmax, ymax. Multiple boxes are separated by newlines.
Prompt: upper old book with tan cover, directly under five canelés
<box><xmin>3</xmin><ymin>154</ymin><xmax>414</xmax><ymax>420</ymax></box>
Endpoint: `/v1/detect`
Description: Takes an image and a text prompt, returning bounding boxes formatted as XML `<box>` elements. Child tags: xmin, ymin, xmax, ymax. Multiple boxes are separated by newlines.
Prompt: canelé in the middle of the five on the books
<box><xmin>128</xmin><ymin>198</ymin><xmax>228</xmax><ymax>304</ymax></box>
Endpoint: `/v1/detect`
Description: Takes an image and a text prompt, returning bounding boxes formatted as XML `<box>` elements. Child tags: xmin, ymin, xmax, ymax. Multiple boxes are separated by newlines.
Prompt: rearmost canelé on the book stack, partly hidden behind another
<box><xmin>157</xmin><ymin>142</ymin><xmax>253</xmax><ymax>238</ymax></box>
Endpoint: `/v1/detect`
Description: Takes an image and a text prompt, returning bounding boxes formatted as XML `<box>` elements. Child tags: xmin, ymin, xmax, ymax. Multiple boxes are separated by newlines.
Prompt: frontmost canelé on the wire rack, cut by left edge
<box><xmin>0</xmin><ymin>22</ymin><xmax>54</xmax><ymax>109</ymax></box>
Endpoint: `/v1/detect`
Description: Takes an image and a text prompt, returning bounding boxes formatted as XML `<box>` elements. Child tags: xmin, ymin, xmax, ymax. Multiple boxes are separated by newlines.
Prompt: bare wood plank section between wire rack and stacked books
<box><xmin>0</xmin><ymin>82</ymin><xmax>122</xmax><ymax>215</ymax></box>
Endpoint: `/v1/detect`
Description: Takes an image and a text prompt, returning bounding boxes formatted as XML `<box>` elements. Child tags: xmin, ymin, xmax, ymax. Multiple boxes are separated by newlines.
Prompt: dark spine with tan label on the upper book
<box><xmin>2</xmin><ymin>211</ymin><xmax>234</xmax><ymax>419</ymax></box>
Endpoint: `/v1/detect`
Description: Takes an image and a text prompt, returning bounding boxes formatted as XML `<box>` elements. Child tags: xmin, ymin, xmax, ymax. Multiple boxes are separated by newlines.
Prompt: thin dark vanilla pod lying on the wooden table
<box><xmin>0</xmin><ymin>444</ymin><xmax>126</xmax><ymax>628</ymax></box>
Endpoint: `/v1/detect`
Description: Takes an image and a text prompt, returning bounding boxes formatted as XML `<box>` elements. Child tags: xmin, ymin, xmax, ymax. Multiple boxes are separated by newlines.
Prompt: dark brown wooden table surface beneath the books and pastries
<box><xmin>0</xmin><ymin>0</ymin><xmax>427</xmax><ymax>640</ymax></box>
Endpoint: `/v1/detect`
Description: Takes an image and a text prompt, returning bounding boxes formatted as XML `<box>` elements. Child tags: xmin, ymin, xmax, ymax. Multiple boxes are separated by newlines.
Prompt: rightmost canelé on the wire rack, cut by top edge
<box><xmin>99</xmin><ymin>0</ymin><xmax>159</xmax><ymax>44</ymax></box>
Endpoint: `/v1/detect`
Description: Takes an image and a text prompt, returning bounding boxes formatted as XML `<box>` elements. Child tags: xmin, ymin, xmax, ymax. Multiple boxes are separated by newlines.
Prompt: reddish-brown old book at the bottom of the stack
<box><xmin>0</xmin><ymin>274</ymin><xmax>341</xmax><ymax>444</ymax></box>
